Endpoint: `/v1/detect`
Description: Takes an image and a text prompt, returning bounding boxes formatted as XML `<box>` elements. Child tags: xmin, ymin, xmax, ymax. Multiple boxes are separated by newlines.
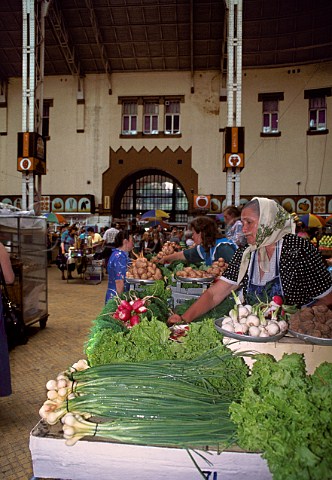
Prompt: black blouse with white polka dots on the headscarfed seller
<box><xmin>223</xmin><ymin>234</ymin><xmax>332</xmax><ymax>306</ymax></box>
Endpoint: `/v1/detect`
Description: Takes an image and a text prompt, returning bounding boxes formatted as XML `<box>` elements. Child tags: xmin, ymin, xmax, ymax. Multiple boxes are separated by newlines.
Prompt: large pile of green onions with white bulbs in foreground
<box><xmin>41</xmin><ymin>347</ymin><xmax>243</xmax><ymax>447</ymax></box>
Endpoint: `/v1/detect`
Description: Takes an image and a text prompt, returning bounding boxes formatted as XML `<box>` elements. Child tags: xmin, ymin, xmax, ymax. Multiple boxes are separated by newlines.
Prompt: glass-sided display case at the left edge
<box><xmin>0</xmin><ymin>215</ymin><xmax>48</xmax><ymax>328</ymax></box>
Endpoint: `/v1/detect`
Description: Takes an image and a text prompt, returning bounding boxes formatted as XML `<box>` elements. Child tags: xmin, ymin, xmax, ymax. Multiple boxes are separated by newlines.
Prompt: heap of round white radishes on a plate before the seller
<box><xmin>222</xmin><ymin>292</ymin><xmax>288</xmax><ymax>337</ymax></box>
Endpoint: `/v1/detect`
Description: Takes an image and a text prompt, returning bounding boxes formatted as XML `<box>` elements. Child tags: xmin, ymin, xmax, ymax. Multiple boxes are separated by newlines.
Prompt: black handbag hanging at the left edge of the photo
<box><xmin>0</xmin><ymin>266</ymin><xmax>28</xmax><ymax>349</ymax></box>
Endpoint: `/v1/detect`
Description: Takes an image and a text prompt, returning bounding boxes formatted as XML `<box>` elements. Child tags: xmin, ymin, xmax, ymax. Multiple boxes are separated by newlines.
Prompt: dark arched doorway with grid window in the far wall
<box><xmin>113</xmin><ymin>169</ymin><xmax>189</xmax><ymax>222</ymax></box>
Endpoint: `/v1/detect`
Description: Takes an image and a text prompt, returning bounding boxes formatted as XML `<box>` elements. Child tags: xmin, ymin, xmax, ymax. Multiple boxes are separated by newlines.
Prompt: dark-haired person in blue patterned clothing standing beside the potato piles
<box><xmin>105</xmin><ymin>230</ymin><xmax>134</xmax><ymax>303</ymax></box>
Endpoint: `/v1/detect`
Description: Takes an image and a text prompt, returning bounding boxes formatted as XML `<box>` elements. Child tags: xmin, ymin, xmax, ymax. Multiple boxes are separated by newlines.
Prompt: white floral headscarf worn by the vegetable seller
<box><xmin>237</xmin><ymin>197</ymin><xmax>295</xmax><ymax>284</ymax></box>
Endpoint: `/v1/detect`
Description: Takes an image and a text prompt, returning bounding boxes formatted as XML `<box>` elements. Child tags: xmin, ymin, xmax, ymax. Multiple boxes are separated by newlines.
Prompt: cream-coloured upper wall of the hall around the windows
<box><xmin>0</xmin><ymin>63</ymin><xmax>332</xmax><ymax>203</ymax></box>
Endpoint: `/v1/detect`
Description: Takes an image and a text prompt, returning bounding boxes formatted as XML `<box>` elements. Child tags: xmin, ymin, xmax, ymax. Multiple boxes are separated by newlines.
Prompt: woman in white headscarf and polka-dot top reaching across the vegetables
<box><xmin>168</xmin><ymin>197</ymin><xmax>332</xmax><ymax>324</ymax></box>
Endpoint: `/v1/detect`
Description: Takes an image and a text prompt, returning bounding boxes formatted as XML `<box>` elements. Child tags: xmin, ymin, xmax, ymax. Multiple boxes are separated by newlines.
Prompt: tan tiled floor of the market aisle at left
<box><xmin>0</xmin><ymin>266</ymin><xmax>107</xmax><ymax>480</ymax></box>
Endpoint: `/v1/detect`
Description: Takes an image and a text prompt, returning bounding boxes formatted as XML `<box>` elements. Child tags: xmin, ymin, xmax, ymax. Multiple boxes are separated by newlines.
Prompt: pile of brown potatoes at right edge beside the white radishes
<box><xmin>289</xmin><ymin>305</ymin><xmax>332</xmax><ymax>339</ymax></box>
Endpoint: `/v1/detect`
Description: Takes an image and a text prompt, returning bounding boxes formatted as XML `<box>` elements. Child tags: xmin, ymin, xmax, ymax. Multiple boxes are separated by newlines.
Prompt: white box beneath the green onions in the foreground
<box><xmin>30</xmin><ymin>422</ymin><xmax>272</xmax><ymax>480</ymax></box>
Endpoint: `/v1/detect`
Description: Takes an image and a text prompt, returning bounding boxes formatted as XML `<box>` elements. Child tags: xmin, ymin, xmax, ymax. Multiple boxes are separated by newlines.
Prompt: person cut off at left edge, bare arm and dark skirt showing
<box><xmin>0</xmin><ymin>243</ymin><xmax>15</xmax><ymax>397</ymax></box>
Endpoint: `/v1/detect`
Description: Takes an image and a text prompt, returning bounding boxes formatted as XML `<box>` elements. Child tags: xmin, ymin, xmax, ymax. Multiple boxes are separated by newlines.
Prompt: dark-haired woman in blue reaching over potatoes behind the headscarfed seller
<box><xmin>160</xmin><ymin>216</ymin><xmax>237</xmax><ymax>265</ymax></box>
